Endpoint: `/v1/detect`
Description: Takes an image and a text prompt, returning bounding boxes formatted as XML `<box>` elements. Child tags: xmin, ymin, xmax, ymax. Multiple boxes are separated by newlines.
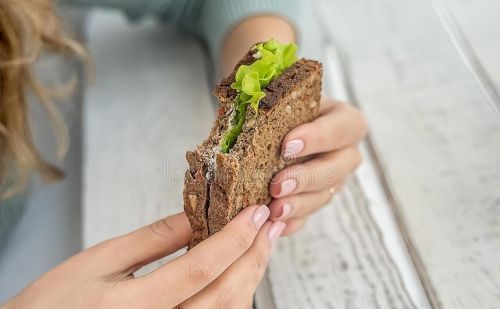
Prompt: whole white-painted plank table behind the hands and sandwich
<box><xmin>83</xmin><ymin>0</ymin><xmax>500</xmax><ymax>309</ymax></box>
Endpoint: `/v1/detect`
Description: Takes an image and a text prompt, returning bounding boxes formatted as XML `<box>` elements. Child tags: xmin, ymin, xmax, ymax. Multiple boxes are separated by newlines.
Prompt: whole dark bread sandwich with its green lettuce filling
<box><xmin>184</xmin><ymin>39</ymin><xmax>322</xmax><ymax>248</ymax></box>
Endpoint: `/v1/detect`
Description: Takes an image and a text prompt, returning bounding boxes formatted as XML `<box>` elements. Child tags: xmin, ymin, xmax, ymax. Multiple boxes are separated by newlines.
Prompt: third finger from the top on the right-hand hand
<box><xmin>269</xmin><ymin>187</ymin><xmax>335</xmax><ymax>221</ymax></box>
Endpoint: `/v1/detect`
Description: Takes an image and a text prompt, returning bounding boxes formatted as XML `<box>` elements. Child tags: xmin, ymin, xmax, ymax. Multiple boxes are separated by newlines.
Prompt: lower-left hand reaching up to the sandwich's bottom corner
<box><xmin>6</xmin><ymin>206</ymin><xmax>285</xmax><ymax>309</ymax></box>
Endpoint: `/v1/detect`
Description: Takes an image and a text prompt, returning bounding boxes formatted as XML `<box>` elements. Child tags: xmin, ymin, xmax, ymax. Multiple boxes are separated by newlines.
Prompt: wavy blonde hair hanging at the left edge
<box><xmin>0</xmin><ymin>0</ymin><xmax>88</xmax><ymax>199</ymax></box>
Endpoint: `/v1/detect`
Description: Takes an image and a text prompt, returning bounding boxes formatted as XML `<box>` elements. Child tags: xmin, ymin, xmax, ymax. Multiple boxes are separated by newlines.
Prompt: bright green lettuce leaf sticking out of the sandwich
<box><xmin>220</xmin><ymin>39</ymin><xmax>297</xmax><ymax>153</ymax></box>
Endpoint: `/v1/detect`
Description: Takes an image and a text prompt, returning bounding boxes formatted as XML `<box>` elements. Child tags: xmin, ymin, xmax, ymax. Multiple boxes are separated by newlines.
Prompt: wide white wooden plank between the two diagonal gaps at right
<box><xmin>320</xmin><ymin>0</ymin><xmax>500</xmax><ymax>308</ymax></box>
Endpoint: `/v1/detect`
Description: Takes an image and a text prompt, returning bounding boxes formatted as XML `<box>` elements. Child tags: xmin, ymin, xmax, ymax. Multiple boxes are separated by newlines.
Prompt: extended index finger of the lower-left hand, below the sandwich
<box><xmin>129</xmin><ymin>205</ymin><xmax>269</xmax><ymax>308</ymax></box>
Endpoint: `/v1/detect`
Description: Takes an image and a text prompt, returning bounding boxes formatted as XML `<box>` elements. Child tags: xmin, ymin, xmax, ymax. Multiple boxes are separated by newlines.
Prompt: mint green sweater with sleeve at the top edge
<box><xmin>0</xmin><ymin>0</ymin><xmax>299</xmax><ymax>247</ymax></box>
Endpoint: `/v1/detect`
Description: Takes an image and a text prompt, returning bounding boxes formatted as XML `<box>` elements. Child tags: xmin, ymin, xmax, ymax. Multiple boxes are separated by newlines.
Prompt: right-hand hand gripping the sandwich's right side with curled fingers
<box><xmin>269</xmin><ymin>100</ymin><xmax>367</xmax><ymax>235</ymax></box>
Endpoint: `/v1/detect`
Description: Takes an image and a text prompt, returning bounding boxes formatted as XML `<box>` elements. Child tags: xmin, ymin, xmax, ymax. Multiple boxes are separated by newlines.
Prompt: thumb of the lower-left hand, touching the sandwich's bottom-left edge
<box><xmin>85</xmin><ymin>212</ymin><xmax>191</xmax><ymax>275</ymax></box>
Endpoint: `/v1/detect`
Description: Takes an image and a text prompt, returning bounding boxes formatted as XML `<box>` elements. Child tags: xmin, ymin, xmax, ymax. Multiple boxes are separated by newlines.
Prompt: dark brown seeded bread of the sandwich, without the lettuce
<box><xmin>184</xmin><ymin>52</ymin><xmax>322</xmax><ymax>248</ymax></box>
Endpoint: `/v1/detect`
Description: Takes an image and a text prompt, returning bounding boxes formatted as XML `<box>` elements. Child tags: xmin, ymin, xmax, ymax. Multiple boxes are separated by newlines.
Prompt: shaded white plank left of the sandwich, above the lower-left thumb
<box><xmin>83</xmin><ymin>11</ymin><xmax>214</xmax><ymax>246</ymax></box>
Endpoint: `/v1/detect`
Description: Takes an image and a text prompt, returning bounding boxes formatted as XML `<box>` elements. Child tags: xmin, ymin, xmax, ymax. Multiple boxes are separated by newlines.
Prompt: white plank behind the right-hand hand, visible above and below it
<box><xmin>257</xmin><ymin>8</ymin><xmax>429</xmax><ymax>308</ymax></box>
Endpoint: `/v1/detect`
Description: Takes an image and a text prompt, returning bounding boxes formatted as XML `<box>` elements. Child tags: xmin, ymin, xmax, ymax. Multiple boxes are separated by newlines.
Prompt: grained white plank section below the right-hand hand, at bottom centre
<box><xmin>269</xmin><ymin>181</ymin><xmax>416</xmax><ymax>308</ymax></box>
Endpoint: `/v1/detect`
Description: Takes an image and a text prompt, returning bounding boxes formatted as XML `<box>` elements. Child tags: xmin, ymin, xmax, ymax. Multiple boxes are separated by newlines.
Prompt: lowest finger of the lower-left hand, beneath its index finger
<box><xmin>182</xmin><ymin>222</ymin><xmax>286</xmax><ymax>309</ymax></box>
